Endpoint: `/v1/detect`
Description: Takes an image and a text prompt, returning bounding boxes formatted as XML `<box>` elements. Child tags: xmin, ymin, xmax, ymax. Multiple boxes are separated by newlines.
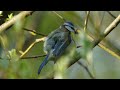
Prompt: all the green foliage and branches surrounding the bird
<box><xmin>0</xmin><ymin>11</ymin><xmax>120</xmax><ymax>79</ymax></box>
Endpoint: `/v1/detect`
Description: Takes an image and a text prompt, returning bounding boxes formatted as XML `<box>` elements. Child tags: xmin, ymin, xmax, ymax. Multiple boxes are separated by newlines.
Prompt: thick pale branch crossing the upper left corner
<box><xmin>0</xmin><ymin>11</ymin><xmax>33</xmax><ymax>34</ymax></box>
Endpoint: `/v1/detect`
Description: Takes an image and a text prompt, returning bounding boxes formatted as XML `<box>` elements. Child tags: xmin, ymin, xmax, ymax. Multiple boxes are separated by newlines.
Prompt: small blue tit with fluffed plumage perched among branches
<box><xmin>38</xmin><ymin>22</ymin><xmax>77</xmax><ymax>74</ymax></box>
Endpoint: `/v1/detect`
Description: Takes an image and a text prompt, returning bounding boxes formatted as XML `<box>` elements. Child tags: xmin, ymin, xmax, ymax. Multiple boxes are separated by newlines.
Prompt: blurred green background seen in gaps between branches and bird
<box><xmin>0</xmin><ymin>11</ymin><xmax>120</xmax><ymax>79</ymax></box>
